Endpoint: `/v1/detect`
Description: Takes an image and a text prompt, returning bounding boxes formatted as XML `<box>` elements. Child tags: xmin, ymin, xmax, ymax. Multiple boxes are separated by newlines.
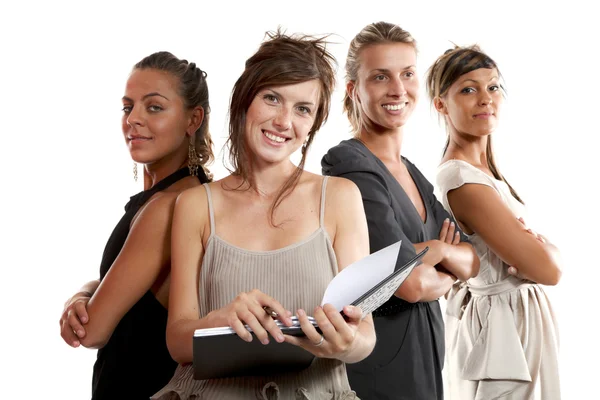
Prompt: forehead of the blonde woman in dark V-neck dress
<box><xmin>358</xmin><ymin>43</ymin><xmax>417</xmax><ymax>73</ymax></box>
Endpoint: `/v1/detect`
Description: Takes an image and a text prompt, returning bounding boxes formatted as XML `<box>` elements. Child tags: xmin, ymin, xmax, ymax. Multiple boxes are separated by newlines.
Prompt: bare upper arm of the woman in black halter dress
<box><xmin>81</xmin><ymin>195</ymin><xmax>175</xmax><ymax>348</ymax></box>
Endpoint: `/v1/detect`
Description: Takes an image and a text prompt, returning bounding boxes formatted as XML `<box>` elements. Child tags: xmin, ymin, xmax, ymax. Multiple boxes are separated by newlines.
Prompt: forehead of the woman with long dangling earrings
<box><xmin>125</xmin><ymin>69</ymin><xmax>179</xmax><ymax>98</ymax></box>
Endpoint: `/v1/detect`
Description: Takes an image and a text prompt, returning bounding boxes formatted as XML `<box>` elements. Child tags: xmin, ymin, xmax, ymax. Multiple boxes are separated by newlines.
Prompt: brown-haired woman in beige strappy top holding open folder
<box><xmin>154</xmin><ymin>33</ymin><xmax>375</xmax><ymax>399</ymax></box>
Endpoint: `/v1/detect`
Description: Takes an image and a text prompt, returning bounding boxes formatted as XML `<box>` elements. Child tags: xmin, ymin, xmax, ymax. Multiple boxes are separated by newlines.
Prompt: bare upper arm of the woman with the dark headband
<box><xmin>448</xmin><ymin>183</ymin><xmax>561</xmax><ymax>285</ymax></box>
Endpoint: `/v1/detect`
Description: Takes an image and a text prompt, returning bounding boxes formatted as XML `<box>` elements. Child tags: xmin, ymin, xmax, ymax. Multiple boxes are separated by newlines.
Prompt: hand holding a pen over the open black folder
<box><xmin>209</xmin><ymin>289</ymin><xmax>292</xmax><ymax>344</ymax></box>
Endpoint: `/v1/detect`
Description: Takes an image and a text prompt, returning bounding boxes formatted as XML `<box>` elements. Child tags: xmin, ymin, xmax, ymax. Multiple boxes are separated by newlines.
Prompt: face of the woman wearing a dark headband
<box><xmin>434</xmin><ymin>68</ymin><xmax>503</xmax><ymax>137</ymax></box>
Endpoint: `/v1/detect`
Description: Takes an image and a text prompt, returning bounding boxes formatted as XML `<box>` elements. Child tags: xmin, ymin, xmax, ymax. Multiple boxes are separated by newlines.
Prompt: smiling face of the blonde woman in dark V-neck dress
<box><xmin>347</xmin><ymin>43</ymin><xmax>419</xmax><ymax>132</ymax></box>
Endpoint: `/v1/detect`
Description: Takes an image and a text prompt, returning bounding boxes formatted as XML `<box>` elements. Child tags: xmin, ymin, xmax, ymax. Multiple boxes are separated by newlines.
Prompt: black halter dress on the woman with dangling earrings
<box><xmin>92</xmin><ymin>167</ymin><xmax>208</xmax><ymax>400</ymax></box>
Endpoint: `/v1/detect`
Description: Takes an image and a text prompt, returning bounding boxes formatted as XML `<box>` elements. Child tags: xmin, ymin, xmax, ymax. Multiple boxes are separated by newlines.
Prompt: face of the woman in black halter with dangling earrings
<box><xmin>122</xmin><ymin>69</ymin><xmax>191</xmax><ymax>164</ymax></box>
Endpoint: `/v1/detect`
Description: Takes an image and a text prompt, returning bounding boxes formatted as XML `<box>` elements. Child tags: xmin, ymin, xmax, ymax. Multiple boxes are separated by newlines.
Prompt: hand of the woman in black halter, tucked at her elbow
<box><xmin>59</xmin><ymin>292</ymin><xmax>92</xmax><ymax>347</ymax></box>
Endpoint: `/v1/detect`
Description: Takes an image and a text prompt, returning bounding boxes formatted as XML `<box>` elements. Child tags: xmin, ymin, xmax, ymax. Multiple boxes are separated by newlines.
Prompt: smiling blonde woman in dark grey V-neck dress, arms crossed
<box><xmin>322</xmin><ymin>22</ymin><xmax>479</xmax><ymax>400</ymax></box>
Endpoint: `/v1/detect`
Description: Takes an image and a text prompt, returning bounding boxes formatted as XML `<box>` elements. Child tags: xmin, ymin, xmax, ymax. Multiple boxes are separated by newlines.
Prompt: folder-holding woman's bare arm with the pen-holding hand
<box><xmin>167</xmin><ymin>187</ymin><xmax>291</xmax><ymax>364</ymax></box>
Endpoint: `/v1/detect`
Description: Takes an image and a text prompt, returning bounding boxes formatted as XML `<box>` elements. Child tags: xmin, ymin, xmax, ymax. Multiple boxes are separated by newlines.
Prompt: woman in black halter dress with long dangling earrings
<box><xmin>60</xmin><ymin>52</ymin><xmax>212</xmax><ymax>400</ymax></box>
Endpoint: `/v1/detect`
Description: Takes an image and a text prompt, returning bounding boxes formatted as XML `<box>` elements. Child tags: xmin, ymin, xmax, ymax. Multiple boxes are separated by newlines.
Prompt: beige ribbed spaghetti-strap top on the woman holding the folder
<box><xmin>153</xmin><ymin>178</ymin><xmax>357</xmax><ymax>400</ymax></box>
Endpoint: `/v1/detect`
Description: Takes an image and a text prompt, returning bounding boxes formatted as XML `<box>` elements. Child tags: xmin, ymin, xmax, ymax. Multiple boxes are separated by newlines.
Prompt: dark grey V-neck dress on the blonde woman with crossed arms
<box><xmin>321</xmin><ymin>139</ymin><xmax>467</xmax><ymax>400</ymax></box>
